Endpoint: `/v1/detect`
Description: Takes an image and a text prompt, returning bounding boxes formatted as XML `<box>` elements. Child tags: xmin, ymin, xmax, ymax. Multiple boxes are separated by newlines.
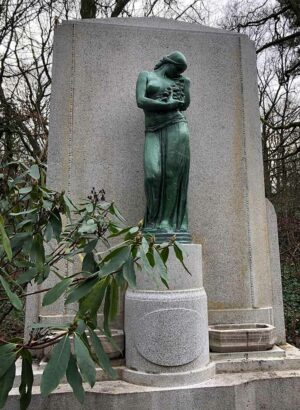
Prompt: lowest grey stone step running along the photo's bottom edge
<box><xmin>4</xmin><ymin>370</ymin><xmax>300</xmax><ymax>410</ymax></box>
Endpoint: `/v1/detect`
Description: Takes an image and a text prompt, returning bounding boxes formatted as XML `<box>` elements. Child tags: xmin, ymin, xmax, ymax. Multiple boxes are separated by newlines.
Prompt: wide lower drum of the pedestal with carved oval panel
<box><xmin>125</xmin><ymin>288</ymin><xmax>209</xmax><ymax>373</ymax></box>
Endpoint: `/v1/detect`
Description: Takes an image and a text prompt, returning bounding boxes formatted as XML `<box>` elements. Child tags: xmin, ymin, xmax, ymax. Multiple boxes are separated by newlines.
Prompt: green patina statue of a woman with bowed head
<box><xmin>136</xmin><ymin>51</ymin><xmax>191</xmax><ymax>243</ymax></box>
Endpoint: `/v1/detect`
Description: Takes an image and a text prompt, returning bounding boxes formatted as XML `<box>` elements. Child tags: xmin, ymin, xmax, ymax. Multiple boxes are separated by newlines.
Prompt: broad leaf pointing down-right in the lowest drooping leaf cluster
<box><xmin>74</xmin><ymin>333</ymin><xmax>96</xmax><ymax>387</ymax></box>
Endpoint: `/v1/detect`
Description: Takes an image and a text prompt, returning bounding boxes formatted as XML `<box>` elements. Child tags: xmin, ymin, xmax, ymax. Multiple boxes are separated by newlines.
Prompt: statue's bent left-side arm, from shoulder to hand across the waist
<box><xmin>136</xmin><ymin>71</ymin><xmax>180</xmax><ymax>112</ymax></box>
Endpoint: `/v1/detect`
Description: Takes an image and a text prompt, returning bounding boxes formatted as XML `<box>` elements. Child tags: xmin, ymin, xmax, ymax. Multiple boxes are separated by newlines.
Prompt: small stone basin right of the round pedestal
<box><xmin>209</xmin><ymin>323</ymin><xmax>275</xmax><ymax>353</ymax></box>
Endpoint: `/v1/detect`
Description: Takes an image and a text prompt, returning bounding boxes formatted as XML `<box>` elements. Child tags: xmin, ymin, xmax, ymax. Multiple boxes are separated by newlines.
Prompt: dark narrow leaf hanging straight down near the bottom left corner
<box><xmin>19</xmin><ymin>350</ymin><xmax>33</xmax><ymax>410</ymax></box>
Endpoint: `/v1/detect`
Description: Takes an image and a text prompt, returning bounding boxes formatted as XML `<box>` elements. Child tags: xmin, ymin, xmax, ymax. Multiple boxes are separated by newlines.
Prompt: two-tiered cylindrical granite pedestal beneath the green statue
<box><xmin>123</xmin><ymin>244</ymin><xmax>215</xmax><ymax>386</ymax></box>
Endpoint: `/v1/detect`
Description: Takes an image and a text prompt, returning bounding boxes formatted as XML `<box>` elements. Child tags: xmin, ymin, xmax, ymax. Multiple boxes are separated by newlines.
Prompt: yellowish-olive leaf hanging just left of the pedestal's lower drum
<box><xmin>79</xmin><ymin>279</ymin><xmax>107</xmax><ymax>325</ymax></box>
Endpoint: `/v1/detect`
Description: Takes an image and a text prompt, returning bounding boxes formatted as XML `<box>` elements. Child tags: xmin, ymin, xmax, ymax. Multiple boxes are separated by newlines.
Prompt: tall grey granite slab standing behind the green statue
<box><xmin>41</xmin><ymin>18</ymin><xmax>284</xmax><ymax>336</ymax></box>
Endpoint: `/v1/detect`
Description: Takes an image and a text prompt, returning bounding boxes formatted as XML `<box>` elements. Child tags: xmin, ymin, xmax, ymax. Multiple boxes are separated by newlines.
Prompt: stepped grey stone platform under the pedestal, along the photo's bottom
<box><xmin>5</xmin><ymin>345</ymin><xmax>300</xmax><ymax>410</ymax></box>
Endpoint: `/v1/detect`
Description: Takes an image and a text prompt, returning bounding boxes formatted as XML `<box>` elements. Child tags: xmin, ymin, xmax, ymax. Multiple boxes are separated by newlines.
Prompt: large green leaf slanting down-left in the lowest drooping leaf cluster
<box><xmin>41</xmin><ymin>335</ymin><xmax>71</xmax><ymax>397</ymax></box>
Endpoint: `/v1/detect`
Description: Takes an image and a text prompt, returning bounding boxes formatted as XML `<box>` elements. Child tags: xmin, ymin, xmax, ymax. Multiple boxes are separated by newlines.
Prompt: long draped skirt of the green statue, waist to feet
<box><xmin>144</xmin><ymin>106</ymin><xmax>190</xmax><ymax>232</ymax></box>
